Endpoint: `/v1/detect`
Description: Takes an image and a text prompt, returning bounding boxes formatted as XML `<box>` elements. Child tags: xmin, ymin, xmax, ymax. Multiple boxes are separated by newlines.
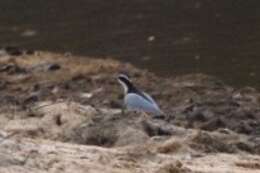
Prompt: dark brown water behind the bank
<box><xmin>0</xmin><ymin>0</ymin><xmax>260</xmax><ymax>88</ymax></box>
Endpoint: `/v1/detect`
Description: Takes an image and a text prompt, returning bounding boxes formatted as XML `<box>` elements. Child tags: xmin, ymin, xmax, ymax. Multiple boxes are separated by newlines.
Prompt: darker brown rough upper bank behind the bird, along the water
<box><xmin>0</xmin><ymin>48</ymin><xmax>260</xmax><ymax>135</ymax></box>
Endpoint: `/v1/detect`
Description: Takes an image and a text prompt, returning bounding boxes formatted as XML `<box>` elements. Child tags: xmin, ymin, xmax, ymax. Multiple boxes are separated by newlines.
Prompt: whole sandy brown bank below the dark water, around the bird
<box><xmin>0</xmin><ymin>49</ymin><xmax>260</xmax><ymax>173</ymax></box>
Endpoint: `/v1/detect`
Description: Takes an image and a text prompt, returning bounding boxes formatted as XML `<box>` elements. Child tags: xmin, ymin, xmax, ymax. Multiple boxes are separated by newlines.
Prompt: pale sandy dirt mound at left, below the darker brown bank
<box><xmin>0</xmin><ymin>102</ymin><xmax>95</xmax><ymax>141</ymax></box>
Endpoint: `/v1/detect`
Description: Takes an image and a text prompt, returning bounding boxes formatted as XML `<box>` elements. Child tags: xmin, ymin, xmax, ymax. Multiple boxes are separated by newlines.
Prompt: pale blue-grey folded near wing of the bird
<box><xmin>125</xmin><ymin>93</ymin><xmax>161</xmax><ymax>114</ymax></box>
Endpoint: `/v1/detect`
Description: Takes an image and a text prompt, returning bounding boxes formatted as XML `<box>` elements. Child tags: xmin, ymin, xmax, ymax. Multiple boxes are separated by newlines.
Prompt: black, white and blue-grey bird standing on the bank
<box><xmin>117</xmin><ymin>74</ymin><xmax>164</xmax><ymax>117</ymax></box>
